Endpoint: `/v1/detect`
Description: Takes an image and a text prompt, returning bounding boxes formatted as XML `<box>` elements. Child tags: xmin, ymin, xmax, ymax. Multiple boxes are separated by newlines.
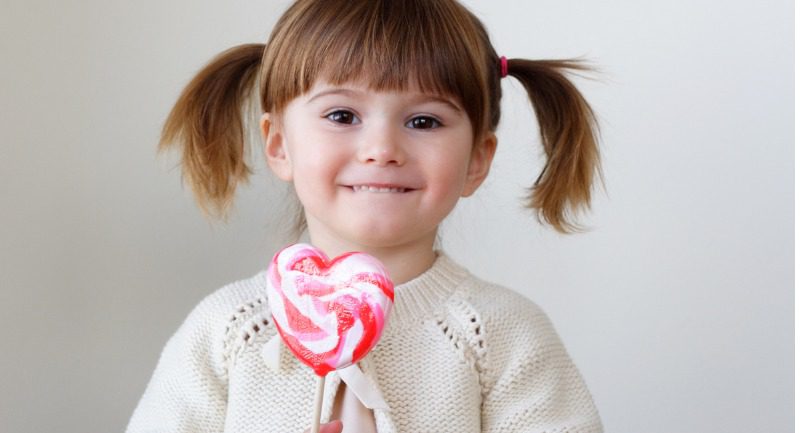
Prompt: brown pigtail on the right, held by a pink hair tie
<box><xmin>508</xmin><ymin>59</ymin><xmax>603</xmax><ymax>234</ymax></box>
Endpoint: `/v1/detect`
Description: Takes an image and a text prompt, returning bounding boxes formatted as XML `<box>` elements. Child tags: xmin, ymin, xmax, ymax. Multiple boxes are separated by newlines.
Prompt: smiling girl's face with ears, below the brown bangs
<box><xmin>261</xmin><ymin>81</ymin><xmax>496</xmax><ymax>254</ymax></box>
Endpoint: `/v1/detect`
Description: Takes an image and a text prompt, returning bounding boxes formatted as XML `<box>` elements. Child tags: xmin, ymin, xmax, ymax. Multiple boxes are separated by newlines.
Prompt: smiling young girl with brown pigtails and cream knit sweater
<box><xmin>128</xmin><ymin>0</ymin><xmax>602</xmax><ymax>433</ymax></box>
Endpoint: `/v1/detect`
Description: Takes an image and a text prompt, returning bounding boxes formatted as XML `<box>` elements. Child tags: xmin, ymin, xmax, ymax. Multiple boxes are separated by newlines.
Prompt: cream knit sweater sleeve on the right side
<box><xmin>480</xmin><ymin>287</ymin><xmax>603</xmax><ymax>433</ymax></box>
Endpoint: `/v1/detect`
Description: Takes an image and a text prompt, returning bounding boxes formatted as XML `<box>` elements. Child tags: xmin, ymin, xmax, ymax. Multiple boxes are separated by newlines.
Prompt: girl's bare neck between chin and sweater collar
<box><xmin>309</xmin><ymin>232</ymin><xmax>436</xmax><ymax>286</ymax></box>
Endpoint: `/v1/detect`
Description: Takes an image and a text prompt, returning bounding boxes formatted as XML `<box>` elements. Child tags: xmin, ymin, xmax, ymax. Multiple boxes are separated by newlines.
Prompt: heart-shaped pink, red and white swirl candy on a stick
<box><xmin>267</xmin><ymin>244</ymin><xmax>394</xmax><ymax>376</ymax></box>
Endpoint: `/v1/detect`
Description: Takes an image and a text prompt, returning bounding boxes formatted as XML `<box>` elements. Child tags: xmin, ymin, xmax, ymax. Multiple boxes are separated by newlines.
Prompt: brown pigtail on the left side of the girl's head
<box><xmin>158</xmin><ymin>44</ymin><xmax>264</xmax><ymax>221</ymax></box>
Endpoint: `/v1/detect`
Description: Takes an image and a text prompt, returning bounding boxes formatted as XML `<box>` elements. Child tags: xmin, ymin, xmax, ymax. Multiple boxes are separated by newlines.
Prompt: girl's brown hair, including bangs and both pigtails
<box><xmin>159</xmin><ymin>0</ymin><xmax>602</xmax><ymax>233</ymax></box>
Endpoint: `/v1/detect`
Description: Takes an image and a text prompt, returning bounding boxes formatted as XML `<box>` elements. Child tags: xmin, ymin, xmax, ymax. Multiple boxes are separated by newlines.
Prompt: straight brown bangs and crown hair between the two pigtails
<box><xmin>261</xmin><ymin>0</ymin><xmax>489</xmax><ymax>134</ymax></box>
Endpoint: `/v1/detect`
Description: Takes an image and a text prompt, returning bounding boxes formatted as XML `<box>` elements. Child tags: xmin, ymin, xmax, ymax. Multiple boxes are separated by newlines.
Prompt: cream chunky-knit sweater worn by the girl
<box><xmin>127</xmin><ymin>253</ymin><xmax>603</xmax><ymax>433</ymax></box>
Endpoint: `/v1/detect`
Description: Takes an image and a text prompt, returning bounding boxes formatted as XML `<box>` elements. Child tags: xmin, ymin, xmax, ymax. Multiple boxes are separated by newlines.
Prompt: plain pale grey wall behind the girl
<box><xmin>0</xmin><ymin>0</ymin><xmax>794</xmax><ymax>433</ymax></box>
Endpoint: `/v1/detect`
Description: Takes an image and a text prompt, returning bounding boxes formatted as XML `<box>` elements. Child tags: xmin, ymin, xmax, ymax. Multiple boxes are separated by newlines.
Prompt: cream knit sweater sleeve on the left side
<box><xmin>126</xmin><ymin>287</ymin><xmax>244</xmax><ymax>433</ymax></box>
